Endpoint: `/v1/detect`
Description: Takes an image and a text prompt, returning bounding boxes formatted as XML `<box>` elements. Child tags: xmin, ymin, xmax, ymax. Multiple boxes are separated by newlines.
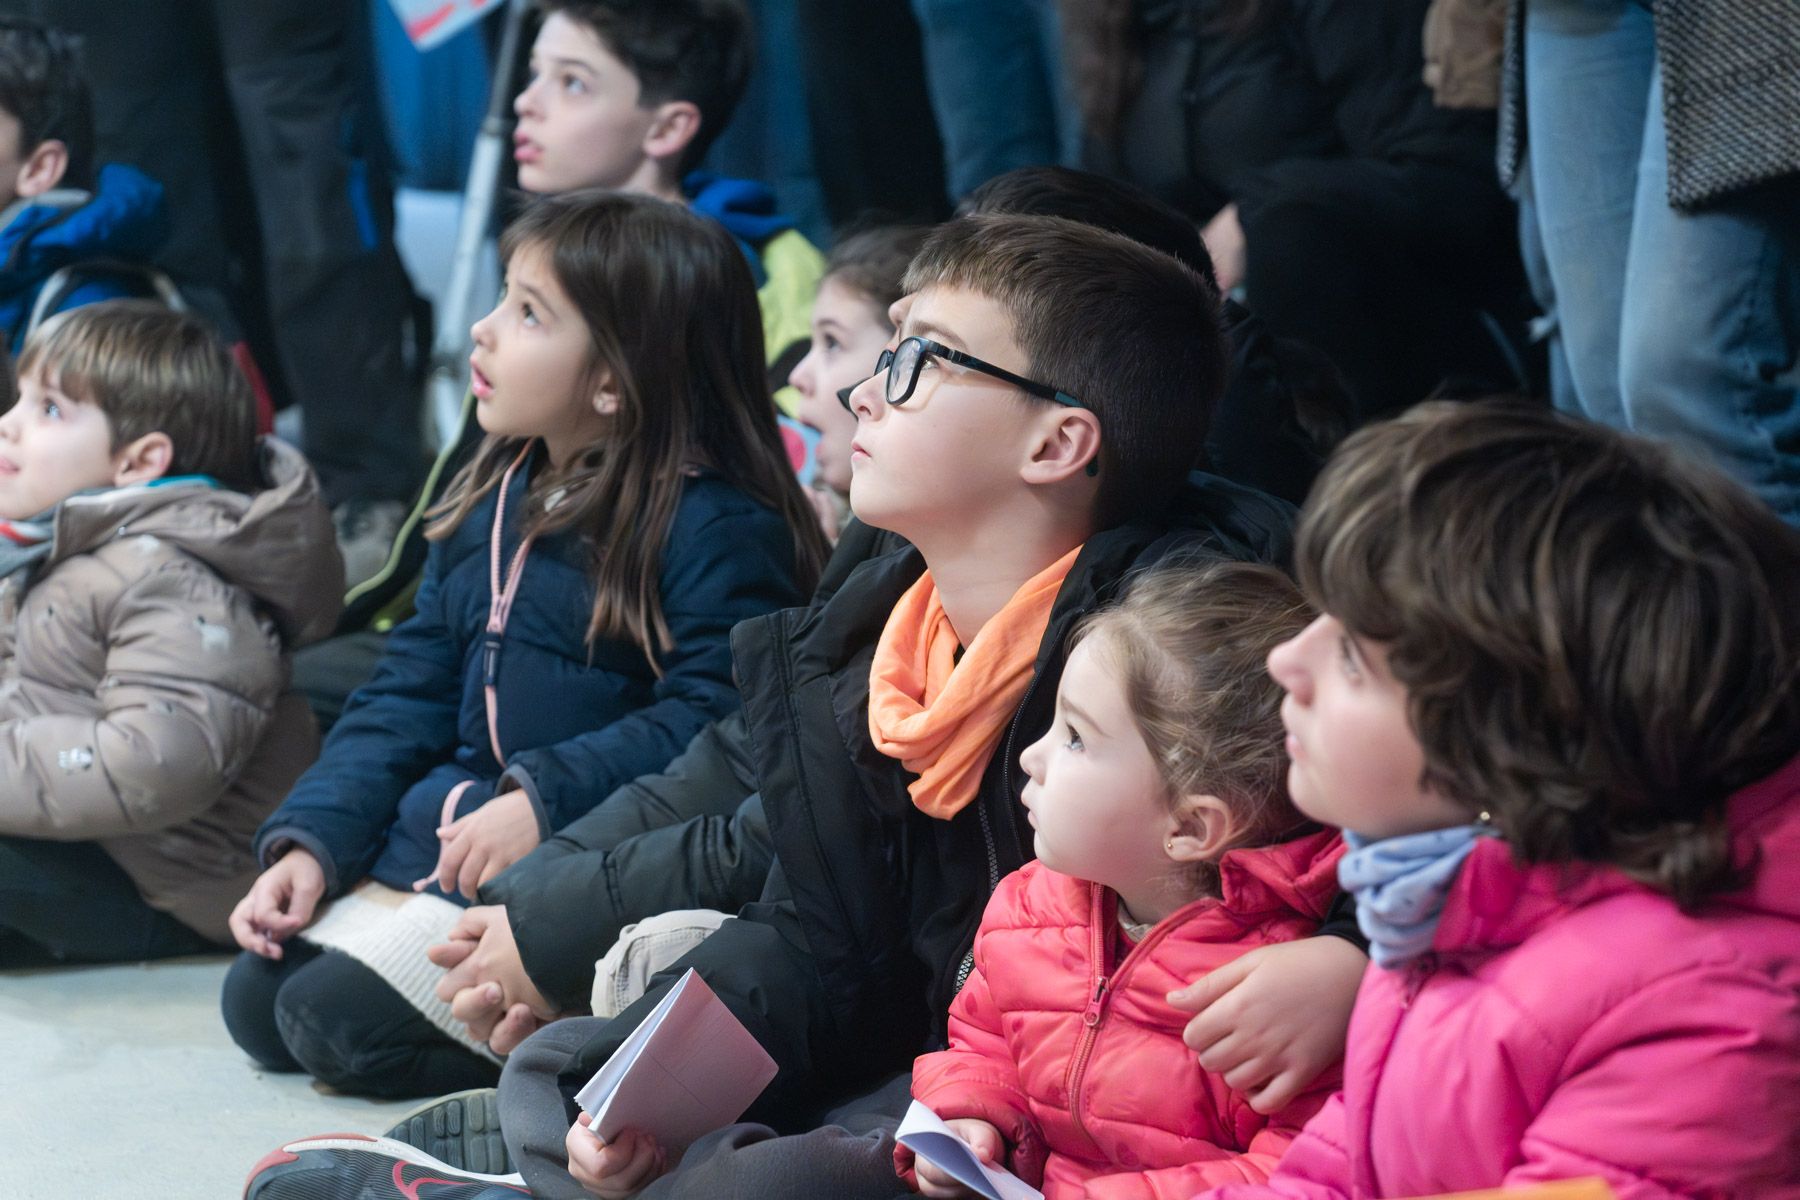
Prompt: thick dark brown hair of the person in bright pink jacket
<box><xmin>1296</xmin><ymin>401</ymin><xmax>1800</xmax><ymax>907</ymax></box>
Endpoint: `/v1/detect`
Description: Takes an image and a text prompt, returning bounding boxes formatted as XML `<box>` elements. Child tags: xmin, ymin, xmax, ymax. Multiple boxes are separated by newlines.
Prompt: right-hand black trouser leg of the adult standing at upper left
<box><xmin>212</xmin><ymin>0</ymin><xmax>423</xmax><ymax>506</ymax></box>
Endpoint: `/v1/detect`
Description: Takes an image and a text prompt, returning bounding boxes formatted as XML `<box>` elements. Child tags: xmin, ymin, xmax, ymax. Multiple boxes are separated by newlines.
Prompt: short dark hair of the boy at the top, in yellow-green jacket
<box><xmin>538</xmin><ymin>0</ymin><xmax>756</xmax><ymax>171</ymax></box>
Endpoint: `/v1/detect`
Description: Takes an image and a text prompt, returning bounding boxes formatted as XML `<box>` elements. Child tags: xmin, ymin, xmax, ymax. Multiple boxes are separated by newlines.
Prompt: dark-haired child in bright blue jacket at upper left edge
<box><xmin>0</xmin><ymin>16</ymin><xmax>166</xmax><ymax>351</ymax></box>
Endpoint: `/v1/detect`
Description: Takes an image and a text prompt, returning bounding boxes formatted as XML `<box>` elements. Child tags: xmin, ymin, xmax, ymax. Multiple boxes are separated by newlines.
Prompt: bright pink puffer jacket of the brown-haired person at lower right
<box><xmin>1217</xmin><ymin>759</ymin><xmax>1800</xmax><ymax>1200</ymax></box>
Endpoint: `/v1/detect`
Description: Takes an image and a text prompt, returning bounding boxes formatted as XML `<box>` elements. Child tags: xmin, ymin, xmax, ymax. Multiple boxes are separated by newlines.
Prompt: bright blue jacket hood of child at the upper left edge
<box><xmin>0</xmin><ymin>162</ymin><xmax>169</xmax><ymax>291</ymax></box>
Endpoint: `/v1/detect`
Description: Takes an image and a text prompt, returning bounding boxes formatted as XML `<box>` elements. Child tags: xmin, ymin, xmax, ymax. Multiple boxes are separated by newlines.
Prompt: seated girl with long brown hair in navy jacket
<box><xmin>225</xmin><ymin>193</ymin><xmax>824</xmax><ymax>1096</ymax></box>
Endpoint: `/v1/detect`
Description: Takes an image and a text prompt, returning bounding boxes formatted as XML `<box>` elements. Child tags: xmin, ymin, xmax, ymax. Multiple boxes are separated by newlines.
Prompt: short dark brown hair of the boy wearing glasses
<box><xmin>905</xmin><ymin>216</ymin><xmax>1226</xmax><ymax>529</ymax></box>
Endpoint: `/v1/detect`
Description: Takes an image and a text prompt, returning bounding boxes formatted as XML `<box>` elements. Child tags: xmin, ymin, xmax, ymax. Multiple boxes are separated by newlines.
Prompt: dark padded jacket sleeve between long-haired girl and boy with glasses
<box><xmin>481</xmin><ymin>712</ymin><xmax>772</xmax><ymax>1009</ymax></box>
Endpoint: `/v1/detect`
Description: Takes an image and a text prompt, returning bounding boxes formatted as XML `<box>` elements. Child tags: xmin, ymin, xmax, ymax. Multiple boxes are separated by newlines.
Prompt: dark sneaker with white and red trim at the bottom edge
<box><xmin>243</xmin><ymin>1133</ymin><xmax>531</xmax><ymax>1200</ymax></box>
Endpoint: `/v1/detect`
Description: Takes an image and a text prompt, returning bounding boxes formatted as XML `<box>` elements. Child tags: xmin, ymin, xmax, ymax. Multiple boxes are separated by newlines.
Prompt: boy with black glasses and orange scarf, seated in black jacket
<box><xmin>250</xmin><ymin>218</ymin><xmax>1363</xmax><ymax>1198</ymax></box>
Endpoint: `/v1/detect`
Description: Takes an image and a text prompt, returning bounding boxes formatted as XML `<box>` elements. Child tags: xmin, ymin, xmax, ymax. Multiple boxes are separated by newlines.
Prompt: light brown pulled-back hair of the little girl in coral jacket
<box><xmin>1076</xmin><ymin>560</ymin><xmax>1312</xmax><ymax>863</ymax></box>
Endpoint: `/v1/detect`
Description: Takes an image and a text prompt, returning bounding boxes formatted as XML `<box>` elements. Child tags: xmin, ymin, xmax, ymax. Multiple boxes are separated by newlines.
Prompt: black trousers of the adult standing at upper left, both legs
<box><xmin>0</xmin><ymin>0</ymin><xmax>423</xmax><ymax>504</ymax></box>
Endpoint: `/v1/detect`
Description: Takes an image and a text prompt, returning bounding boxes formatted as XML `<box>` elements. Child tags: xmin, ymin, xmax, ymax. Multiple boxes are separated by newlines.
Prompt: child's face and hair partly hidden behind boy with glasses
<box><xmin>788</xmin><ymin>225</ymin><xmax>931</xmax><ymax>542</ymax></box>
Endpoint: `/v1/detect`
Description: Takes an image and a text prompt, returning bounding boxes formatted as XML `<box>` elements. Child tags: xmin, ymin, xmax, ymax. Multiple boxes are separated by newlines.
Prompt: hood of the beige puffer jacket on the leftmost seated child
<box><xmin>49</xmin><ymin>437</ymin><xmax>344</xmax><ymax>646</ymax></box>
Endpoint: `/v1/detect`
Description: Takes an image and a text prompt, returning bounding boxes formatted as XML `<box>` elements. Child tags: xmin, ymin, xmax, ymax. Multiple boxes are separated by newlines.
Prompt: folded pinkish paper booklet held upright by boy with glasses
<box><xmin>576</xmin><ymin>968</ymin><xmax>776</xmax><ymax>1151</ymax></box>
